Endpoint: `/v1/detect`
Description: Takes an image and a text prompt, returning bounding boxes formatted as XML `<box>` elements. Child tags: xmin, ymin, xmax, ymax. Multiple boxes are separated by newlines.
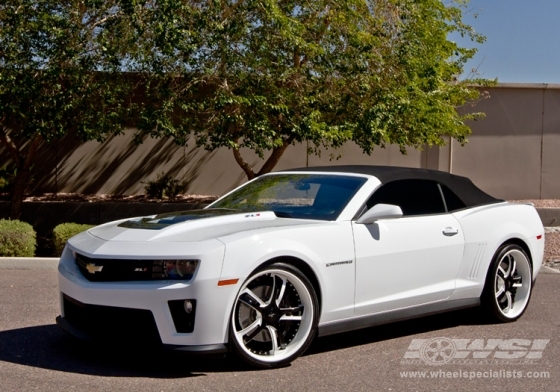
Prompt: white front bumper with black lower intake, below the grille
<box><xmin>57</xmin><ymin>242</ymin><xmax>239</xmax><ymax>354</ymax></box>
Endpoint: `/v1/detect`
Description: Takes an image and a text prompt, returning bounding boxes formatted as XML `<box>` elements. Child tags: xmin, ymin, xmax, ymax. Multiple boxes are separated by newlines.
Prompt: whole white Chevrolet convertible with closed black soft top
<box><xmin>57</xmin><ymin>166</ymin><xmax>544</xmax><ymax>368</ymax></box>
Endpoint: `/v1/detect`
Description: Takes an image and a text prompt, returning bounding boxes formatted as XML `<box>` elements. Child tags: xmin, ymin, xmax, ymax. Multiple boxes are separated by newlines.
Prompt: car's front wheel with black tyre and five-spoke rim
<box><xmin>230</xmin><ymin>263</ymin><xmax>319</xmax><ymax>368</ymax></box>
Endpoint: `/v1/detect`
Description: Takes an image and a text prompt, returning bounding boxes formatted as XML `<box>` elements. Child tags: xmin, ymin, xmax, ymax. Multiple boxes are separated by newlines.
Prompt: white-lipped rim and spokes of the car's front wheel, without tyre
<box><xmin>231</xmin><ymin>268</ymin><xmax>315</xmax><ymax>364</ymax></box>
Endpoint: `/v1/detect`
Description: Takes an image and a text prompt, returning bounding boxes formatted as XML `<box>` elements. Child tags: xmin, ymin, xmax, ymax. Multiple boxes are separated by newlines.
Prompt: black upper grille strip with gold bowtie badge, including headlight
<box><xmin>74</xmin><ymin>253</ymin><xmax>197</xmax><ymax>282</ymax></box>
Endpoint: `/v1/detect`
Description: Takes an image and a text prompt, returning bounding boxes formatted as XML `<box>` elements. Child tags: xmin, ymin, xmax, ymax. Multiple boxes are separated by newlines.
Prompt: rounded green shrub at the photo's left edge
<box><xmin>0</xmin><ymin>219</ymin><xmax>37</xmax><ymax>257</ymax></box>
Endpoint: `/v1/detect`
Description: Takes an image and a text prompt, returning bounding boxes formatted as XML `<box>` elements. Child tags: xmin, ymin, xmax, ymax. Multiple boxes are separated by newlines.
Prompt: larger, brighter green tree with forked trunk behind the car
<box><xmin>133</xmin><ymin>0</ymin><xmax>491</xmax><ymax>179</ymax></box>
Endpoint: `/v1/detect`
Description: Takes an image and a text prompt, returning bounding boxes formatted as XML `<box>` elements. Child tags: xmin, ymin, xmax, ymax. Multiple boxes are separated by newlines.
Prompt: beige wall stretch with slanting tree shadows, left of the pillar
<box><xmin>36</xmin><ymin>134</ymin><xmax>422</xmax><ymax>195</ymax></box>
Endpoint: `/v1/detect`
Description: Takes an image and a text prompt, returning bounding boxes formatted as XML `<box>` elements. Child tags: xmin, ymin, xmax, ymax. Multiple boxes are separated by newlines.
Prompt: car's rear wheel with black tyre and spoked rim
<box><xmin>482</xmin><ymin>244</ymin><xmax>533</xmax><ymax>322</ymax></box>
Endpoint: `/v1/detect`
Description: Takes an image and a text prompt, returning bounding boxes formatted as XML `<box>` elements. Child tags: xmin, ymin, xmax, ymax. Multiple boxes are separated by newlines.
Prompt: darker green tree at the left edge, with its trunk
<box><xmin>0</xmin><ymin>0</ymin><xmax>134</xmax><ymax>219</ymax></box>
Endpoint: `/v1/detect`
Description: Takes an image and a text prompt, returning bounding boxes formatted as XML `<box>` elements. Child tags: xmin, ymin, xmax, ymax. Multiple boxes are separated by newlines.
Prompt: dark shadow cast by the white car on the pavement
<box><xmin>0</xmin><ymin>308</ymin><xmax>486</xmax><ymax>379</ymax></box>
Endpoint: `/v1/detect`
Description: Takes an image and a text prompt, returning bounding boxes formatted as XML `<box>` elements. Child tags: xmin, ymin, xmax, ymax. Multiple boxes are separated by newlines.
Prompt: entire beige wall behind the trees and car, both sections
<box><xmin>0</xmin><ymin>84</ymin><xmax>560</xmax><ymax>199</ymax></box>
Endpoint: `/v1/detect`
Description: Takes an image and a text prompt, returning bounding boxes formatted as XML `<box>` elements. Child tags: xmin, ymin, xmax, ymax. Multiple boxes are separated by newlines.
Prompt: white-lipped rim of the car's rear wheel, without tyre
<box><xmin>493</xmin><ymin>249</ymin><xmax>533</xmax><ymax>319</ymax></box>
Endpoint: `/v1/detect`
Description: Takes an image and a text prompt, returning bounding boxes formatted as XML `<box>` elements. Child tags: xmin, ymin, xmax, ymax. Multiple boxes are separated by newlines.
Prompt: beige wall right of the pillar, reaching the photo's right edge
<box><xmin>450</xmin><ymin>84</ymin><xmax>560</xmax><ymax>199</ymax></box>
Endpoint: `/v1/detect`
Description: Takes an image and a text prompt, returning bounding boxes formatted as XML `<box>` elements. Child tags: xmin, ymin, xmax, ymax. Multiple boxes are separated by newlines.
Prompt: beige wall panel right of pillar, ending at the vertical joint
<box><xmin>451</xmin><ymin>88</ymin><xmax>543</xmax><ymax>199</ymax></box>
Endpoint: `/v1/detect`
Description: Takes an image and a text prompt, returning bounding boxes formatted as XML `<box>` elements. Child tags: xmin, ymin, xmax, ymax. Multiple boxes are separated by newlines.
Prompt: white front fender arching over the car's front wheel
<box><xmin>220</xmin><ymin>222</ymin><xmax>355</xmax><ymax>330</ymax></box>
